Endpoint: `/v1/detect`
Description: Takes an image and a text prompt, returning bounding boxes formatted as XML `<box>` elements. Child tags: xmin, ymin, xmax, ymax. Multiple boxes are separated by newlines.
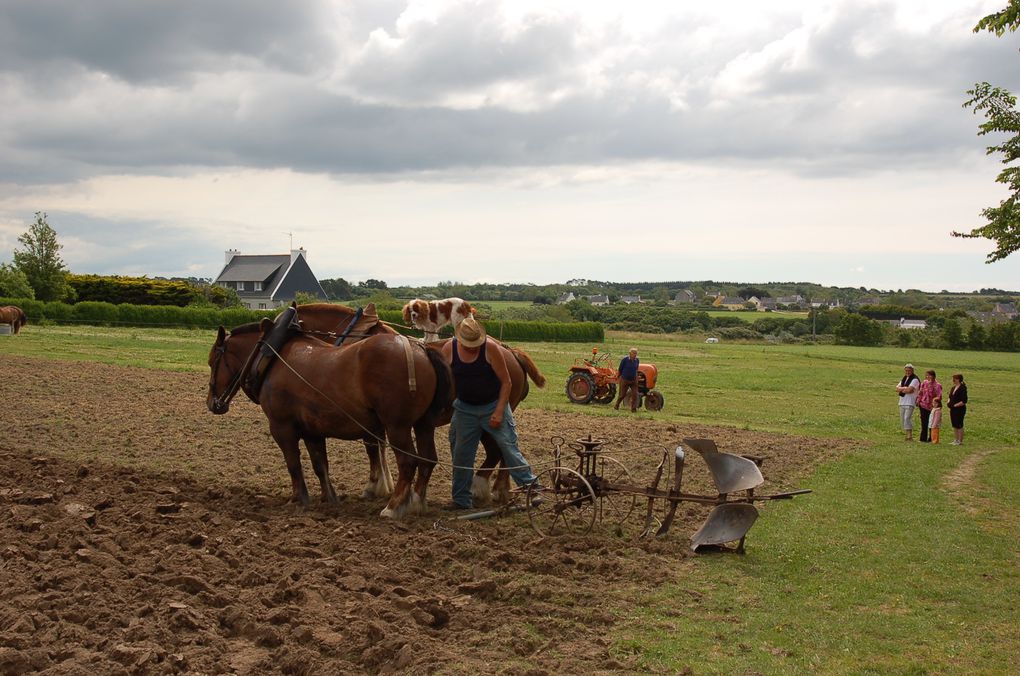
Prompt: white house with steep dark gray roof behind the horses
<box><xmin>213</xmin><ymin>249</ymin><xmax>326</xmax><ymax>310</ymax></box>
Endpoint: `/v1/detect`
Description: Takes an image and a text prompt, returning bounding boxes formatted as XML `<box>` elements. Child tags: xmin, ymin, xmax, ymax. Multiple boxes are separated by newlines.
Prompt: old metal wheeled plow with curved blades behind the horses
<box><xmin>510</xmin><ymin>435</ymin><xmax>811</xmax><ymax>553</ymax></box>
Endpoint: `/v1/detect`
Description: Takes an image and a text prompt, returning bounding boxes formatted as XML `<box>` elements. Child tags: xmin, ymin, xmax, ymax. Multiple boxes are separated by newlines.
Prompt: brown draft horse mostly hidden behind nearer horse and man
<box><xmin>298</xmin><ymin>303</ymin><xmax>546</xmax><ymax>506</ymax></box>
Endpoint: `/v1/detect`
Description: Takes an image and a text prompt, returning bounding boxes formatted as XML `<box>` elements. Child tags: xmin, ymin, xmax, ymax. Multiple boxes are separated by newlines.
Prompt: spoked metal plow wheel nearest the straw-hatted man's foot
<box><xmin>527</xmin><ymin>467</ymin><xmax>596</xmax><ymax>537</ymax></box>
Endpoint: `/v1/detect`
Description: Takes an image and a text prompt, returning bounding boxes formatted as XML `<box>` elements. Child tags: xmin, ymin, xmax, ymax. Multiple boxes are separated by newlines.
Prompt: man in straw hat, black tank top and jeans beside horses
<box><xmin>443</xmin><ymin>317</ymin><xmax>537</xmax><ymax>510</ymax></box>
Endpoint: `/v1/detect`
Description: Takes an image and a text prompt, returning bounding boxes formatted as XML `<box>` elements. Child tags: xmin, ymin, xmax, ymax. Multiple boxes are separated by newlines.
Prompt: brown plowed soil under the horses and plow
<box><xmin>0</xmin><ymin>355</ymin><xmax>846</xmax><ymax>674</ymax></box>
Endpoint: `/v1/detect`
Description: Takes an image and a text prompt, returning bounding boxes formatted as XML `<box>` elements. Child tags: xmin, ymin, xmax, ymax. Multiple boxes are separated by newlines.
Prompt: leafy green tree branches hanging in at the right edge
<box><xmin>953</xmin><ymin>0</ymin><xmax>1020</xmax><ymax>263</ymax></box>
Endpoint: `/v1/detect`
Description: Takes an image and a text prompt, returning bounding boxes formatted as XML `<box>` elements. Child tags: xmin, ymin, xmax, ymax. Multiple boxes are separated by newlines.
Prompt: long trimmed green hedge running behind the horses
<box><xmin>0</xmin><ymin>298</ymin><xmax>605</xmax><ymax>343</ymax></box>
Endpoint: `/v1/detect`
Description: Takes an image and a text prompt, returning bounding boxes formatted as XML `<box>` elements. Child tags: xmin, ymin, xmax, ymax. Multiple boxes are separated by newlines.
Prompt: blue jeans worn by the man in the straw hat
<box><xmin>450</xmin><ymin>399</ymin><xmax>536</xmax><ymax>507</ymax></box>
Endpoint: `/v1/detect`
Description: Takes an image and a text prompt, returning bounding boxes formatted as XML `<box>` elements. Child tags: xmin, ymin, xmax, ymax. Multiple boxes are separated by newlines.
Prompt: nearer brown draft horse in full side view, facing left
<box><xmin>206</xmin><ymin>319</ymin><xmax>452</xmax><ymax>519</ymax></box>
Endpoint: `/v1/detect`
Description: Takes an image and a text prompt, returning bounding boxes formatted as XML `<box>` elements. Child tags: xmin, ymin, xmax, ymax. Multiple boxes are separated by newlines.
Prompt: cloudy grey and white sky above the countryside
<box><xmin>0</xmin><ymin>0</ymin><xmax>1020</xmax><ymax>291</ymax></box>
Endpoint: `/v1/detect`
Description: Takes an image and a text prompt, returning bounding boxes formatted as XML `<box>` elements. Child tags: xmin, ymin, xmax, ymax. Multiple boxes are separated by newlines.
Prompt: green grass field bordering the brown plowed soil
<box><xmin>0</xmin><ymin>326</ymin><xmax>1020</xmax><ymax>674</ymax></box>
